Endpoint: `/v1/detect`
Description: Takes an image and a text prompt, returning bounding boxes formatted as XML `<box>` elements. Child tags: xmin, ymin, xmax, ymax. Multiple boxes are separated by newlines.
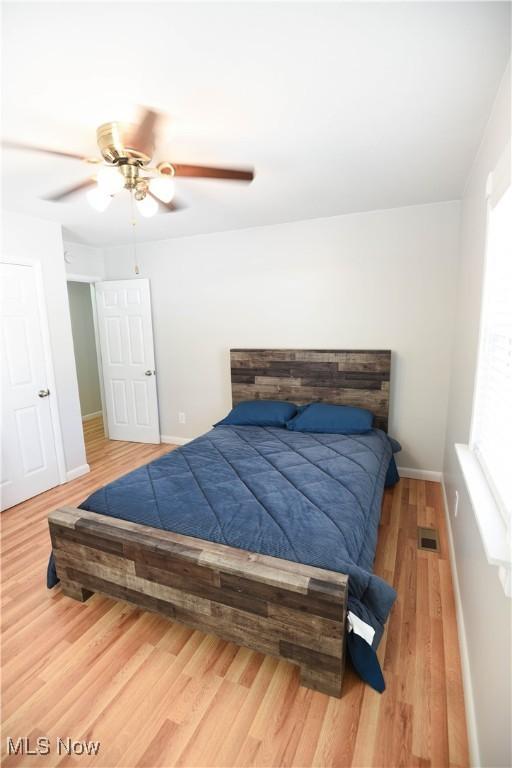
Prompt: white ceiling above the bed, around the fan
<box><xmin>3</xmin><ymin>2</ymin><xmax>510</xmax><ymax>245</ymax></box>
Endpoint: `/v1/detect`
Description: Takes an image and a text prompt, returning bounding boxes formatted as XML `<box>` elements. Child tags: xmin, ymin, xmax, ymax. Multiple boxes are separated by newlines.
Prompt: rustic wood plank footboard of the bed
<box><xmin>49</xmin><ymin>507</ymin><xmax>348</xmax><ymax>697</ymax></box>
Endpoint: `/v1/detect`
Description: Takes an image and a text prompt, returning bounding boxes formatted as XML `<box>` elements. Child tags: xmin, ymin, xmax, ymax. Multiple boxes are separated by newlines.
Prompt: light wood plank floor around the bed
<box><xmin>2</xmin><ymin>420</ymin><xmax>468</xmax><ymax>768</ymax></box>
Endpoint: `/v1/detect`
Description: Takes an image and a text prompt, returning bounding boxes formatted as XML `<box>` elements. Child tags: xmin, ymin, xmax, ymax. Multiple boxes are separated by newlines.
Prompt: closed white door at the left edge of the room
<box><xmin>0</xmin><ymin>263</ymin><xmax>60</xmax><ymax>509</ymax></box>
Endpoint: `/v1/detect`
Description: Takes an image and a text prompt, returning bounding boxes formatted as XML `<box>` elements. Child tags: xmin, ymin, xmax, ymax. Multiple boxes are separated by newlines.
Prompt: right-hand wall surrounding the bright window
<box><xmin>444</xmin><ymin>63</ymin><xmax>512</xmax><ymax>766</ymax></box>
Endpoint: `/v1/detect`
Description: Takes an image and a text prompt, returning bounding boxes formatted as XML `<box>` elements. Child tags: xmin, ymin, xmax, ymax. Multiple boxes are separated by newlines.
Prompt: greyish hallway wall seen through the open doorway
<box><xmin>68</xmin><ymin>281</ymin><xmax>101</xmax><ymax>417</ymax></box>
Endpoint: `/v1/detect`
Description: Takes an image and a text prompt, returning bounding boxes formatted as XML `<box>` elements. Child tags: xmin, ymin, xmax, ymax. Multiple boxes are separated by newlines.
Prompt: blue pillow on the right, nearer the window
<box><xmin>286</xmin><ymin>403</ymin><xmax>373</xmax><ymax>435</ymax></box>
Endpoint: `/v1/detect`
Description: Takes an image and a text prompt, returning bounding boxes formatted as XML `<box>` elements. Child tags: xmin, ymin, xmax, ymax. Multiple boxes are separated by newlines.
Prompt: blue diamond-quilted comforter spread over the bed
<box><xmin>49</xmin><ymin>426</ymin><xmax>396</xmax><ymax>688</ymax></box>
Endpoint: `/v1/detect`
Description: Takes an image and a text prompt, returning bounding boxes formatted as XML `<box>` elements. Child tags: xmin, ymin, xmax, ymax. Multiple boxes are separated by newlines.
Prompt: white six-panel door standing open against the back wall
<box><xmin>95</xmin><ymin>278</ymin><xmax>160</xmax><ymax>443</ymax></box>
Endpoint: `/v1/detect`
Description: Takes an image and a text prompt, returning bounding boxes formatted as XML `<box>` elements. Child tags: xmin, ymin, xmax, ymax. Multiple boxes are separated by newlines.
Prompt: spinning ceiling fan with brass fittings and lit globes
<box><xmin>3</xmin><ymin>108</ymin><xmax>254</xmax><ymax>217</ymax></box>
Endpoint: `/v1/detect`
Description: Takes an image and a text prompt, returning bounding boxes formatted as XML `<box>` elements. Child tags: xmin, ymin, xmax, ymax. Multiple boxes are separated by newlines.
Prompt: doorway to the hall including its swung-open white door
<box><xmin>67</xmin><ymin>274</ymin><xmax>160</xmax><ymax>452</ymax></box>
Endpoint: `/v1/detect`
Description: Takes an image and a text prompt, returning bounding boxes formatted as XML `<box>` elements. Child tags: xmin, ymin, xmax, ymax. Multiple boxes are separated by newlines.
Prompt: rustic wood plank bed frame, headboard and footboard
<box><xmin>48</xmin><ymin>349</ymin><xmax>391</xmax><ymax>697</ymax></box>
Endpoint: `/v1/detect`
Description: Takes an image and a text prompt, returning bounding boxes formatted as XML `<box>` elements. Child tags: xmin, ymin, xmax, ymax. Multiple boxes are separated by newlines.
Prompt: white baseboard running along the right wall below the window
<box><xmin>441</xmin><ymin>478</ymin><xmax>482</xmax><ymax>766</ymax></box>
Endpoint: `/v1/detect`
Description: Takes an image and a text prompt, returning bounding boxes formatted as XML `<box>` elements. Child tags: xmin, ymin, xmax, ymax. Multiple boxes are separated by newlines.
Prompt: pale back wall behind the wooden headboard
<box><xmin>104</xmin><ymin>202</ymin><xmax>459</xmax><ymax>472</ymax></box>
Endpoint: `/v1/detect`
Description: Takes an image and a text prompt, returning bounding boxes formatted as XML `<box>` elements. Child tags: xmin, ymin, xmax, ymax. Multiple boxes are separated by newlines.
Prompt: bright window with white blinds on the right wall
<box><xmin>471</xmin><ymin>182</ymin><xmax>512</xmax><ymax>523</ymax></box>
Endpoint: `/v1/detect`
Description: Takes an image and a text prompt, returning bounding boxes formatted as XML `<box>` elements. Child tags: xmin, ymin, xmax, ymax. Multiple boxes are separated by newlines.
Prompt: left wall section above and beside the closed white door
<box><xmin>2</xmin><ymin>211</ymin><xmax>86</xmax><ymax>472</ymax></box>
